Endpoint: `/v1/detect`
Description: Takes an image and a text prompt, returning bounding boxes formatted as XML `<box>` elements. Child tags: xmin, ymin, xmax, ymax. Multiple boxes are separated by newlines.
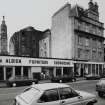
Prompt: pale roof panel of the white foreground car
<box><xmin>32</xmin><ymin>83</ymin><xmax>69</xmax><ymax>91</ymax></box>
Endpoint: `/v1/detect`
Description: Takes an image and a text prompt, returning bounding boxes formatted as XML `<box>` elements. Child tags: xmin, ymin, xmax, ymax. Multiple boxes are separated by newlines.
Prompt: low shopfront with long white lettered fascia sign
<box><xmin>0</xmin><ymin>56</ymin><xmax>74</xmax><ymax>81</ymax></box>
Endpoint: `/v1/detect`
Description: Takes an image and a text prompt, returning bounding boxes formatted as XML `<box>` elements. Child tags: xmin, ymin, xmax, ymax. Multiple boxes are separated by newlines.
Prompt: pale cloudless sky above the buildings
<box><xmin>0</xmin><ymin>0</ymin><xmax>105</xmax><ymax>38</ymax></box>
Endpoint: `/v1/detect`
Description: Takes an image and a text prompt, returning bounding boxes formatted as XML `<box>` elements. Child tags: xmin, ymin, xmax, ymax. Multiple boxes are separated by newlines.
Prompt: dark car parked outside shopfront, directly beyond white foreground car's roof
<box><xmin>51</xmin><ymin>75</ymin><xmax>76</xmax><ymax>82</ymax></box>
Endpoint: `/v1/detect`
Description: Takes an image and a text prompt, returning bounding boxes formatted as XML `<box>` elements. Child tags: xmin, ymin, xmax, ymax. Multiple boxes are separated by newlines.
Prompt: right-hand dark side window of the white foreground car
<box><xmin>59</xmin><ymin>87</ymin><xmax>78</xmax><ymax>100</ymax></box>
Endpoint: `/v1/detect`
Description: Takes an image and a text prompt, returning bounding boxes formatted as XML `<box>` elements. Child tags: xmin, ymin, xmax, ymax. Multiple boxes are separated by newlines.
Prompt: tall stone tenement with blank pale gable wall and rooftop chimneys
<box><xmin>51</xmin><ymin>0</ymin><xmax>104</xmax><ymax>77</ymax></box>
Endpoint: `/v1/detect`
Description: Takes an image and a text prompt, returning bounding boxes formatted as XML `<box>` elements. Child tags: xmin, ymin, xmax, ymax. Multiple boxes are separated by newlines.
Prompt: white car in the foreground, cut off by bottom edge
<box><xmin>14</xmin><ymin>83</ymin><xmax>97</xmax><ymax>105</ymax></box>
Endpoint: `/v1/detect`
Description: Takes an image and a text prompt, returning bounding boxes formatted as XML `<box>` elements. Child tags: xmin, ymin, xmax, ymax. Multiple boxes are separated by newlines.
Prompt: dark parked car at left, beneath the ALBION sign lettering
<box><xmin>6</xmin><ymin>76</ymin><xmax>38</xmax><ymax>87</ymax></box>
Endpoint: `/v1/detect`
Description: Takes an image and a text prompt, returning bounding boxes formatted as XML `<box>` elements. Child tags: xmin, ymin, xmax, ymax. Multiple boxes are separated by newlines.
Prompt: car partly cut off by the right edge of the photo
<box><xmin>96</xmin><ymin>78</ymin><xmax>105</xmax><ymax>97</ymax></box>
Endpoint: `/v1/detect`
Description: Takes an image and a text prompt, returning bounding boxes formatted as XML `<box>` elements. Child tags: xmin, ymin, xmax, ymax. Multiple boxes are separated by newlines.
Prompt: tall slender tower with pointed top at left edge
<box><xmin>0</xmin><ymin>16</ymin><xmax>7</xmax><ymax>55</ymax></box>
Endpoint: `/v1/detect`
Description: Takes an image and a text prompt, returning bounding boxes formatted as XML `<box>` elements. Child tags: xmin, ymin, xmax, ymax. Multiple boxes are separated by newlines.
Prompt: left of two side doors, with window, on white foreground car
<box><xmin>37</xmin><ymin>89</ymin><xmax>60</xmax><ymax>105</ymax></box>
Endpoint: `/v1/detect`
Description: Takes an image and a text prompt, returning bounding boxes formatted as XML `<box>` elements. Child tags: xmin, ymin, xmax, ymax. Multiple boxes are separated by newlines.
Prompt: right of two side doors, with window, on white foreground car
<box><xmin>59</xmin><ymin>87</ymin><xmax>83</xmax><ymax>105</ymax></box>
